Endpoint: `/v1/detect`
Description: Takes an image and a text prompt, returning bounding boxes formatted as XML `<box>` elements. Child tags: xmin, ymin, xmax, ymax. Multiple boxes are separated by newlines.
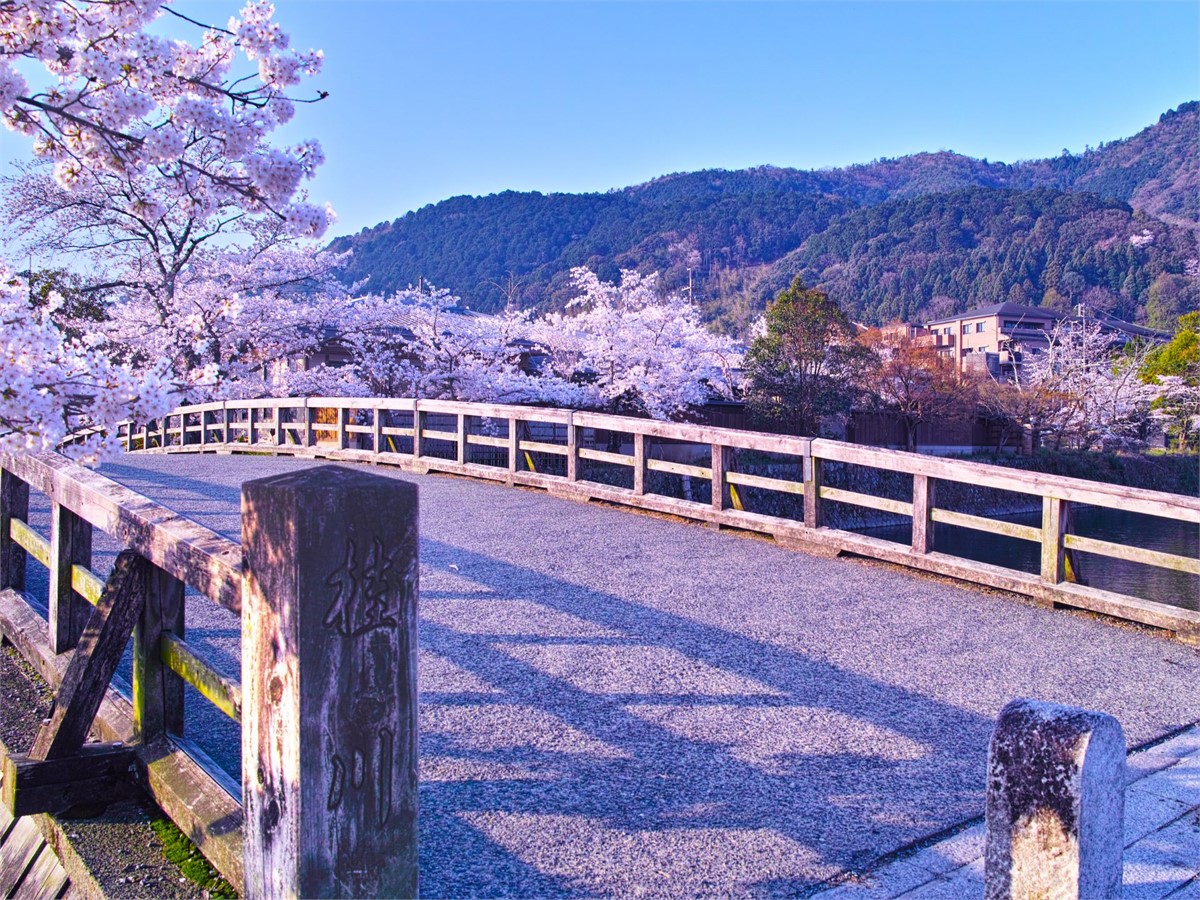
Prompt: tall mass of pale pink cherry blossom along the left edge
<box><xmin>0</xmin><ymin>0</ymin><xmax>330</xmax><ymax>451</ymax></box>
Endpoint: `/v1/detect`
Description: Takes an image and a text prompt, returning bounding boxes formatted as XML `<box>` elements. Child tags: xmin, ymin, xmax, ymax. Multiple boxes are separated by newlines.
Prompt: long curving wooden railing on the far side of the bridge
<box><xmin>120</xmin><ymin>397</ymin><xmax>1200</xmax><ymax>642</ymax></box>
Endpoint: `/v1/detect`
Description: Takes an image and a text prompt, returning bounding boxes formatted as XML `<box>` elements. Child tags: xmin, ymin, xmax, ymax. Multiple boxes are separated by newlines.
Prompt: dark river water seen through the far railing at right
<box><xmin>869</xmin><ymin>506</ymin><xmax>1200</xmax><ymax>610</ymax></box>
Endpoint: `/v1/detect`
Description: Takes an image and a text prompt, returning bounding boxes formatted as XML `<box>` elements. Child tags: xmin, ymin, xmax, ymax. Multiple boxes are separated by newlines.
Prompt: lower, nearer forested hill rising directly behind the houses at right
<box><xmin>758</xmin><ymin>188</ymin><xmax>1200</xmax><ymax>328</ymax></box>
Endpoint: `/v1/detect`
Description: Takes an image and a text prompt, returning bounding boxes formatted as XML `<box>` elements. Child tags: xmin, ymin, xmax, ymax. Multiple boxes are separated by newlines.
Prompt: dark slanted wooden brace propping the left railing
<box><xmin>29</xmin><ymin>550</ymin><xmax>149</xmax><ymax>760</ymax></box>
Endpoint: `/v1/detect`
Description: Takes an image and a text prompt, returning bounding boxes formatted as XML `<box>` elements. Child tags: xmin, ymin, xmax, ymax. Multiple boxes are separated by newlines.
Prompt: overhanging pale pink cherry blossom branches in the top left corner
<box><xmin>0</xmin><ymin>0</ymin><xmax>328</xmax><ymax>236</ymax></box>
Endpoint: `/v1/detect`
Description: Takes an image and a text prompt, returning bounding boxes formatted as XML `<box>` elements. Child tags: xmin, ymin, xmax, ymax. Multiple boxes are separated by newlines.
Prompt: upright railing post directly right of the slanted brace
<box><xmin>133</xmin><ymin>565</ymin><xmax>184</xmax><ymax>743</ymax></box>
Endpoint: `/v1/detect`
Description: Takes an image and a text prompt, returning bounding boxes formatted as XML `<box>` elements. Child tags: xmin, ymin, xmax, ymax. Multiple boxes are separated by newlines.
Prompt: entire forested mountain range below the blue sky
<box><xmin>334</xmin><ymin>102</ymin><xmax>1200</xmax><ymax>330</ymax></box>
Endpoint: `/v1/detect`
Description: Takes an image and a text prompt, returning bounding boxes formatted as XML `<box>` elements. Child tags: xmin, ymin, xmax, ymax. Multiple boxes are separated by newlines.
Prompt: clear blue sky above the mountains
<box><xmin>0</xmin><ymin>0</ymin><xmax>1200</xmax><ymax>240</ymax></box>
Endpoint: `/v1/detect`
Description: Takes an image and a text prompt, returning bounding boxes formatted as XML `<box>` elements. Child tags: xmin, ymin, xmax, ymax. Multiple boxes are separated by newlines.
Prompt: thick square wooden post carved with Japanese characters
<box><xmin>241</xmin><ymin>466</ymin><xmax>418</xmax><ymax>900</ymax></box>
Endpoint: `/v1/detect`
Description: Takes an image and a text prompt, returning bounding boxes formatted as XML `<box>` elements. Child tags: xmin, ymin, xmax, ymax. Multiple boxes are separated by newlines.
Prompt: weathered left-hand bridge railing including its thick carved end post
<box><xmin>0</xmin><ymin>454</ymin><xmax>416</xmax><ymax>898</ymax></box>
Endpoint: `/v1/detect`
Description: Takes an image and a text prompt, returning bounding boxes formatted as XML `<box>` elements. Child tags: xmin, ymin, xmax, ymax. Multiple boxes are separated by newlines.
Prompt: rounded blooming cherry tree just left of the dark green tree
<box><xmin>532</xmin><ymin>268</ymin><xmax>740</xmax><ymax>419</ymax></box>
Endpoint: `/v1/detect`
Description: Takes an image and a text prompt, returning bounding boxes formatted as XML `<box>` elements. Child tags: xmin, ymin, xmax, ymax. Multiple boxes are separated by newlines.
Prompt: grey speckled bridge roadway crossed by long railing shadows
<box><xmin>16</xmin><ymin>455</ymin><xmax>1200</xmax><ymax>896</ymax></box>
